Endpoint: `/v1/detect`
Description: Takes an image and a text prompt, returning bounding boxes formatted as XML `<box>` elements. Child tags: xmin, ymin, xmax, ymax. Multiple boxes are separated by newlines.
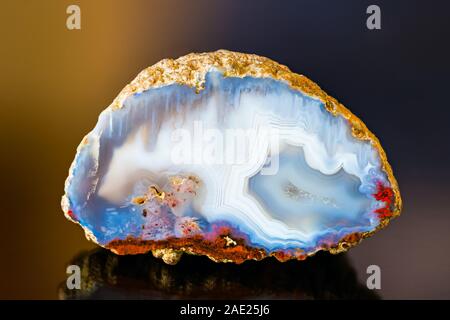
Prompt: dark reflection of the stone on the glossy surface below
<box><xmin>59</xmin><ymin>249</ymin><xmax>379</xmax><ymax>299</ymax></box>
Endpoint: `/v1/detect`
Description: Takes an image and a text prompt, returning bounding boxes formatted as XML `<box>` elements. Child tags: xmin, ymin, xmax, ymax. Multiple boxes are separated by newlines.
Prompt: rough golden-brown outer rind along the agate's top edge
<box><xmin>61</xmin><ymin>50</ymin><xmax>402</xmax><ymax>260</ymax></box>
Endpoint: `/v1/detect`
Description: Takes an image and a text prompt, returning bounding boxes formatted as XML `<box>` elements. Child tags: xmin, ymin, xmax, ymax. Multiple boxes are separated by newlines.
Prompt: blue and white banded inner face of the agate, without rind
<box><xmin>66</xmin><ymin>70</ymin><xmax>389</xmax><ymax>253</ymax></box>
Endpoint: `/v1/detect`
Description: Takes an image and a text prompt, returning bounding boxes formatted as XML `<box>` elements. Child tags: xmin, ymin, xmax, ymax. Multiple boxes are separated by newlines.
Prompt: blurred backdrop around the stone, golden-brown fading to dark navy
<box><xmin>0</xmin><ymin>0</ymin><xmax>450</xmax><ymax>299</ymax></box>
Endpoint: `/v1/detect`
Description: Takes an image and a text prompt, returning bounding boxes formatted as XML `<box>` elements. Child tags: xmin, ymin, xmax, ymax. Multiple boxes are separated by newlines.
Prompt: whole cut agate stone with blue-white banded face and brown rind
<box><xmin>62</xmin><ymin>50</ymin><xmax>401</xmax><ymax>264</ymax></box>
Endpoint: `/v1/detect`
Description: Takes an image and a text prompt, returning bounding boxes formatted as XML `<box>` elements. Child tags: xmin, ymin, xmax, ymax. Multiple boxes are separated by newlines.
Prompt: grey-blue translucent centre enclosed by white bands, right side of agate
<box><xmin>249</xmin><ymin>146</ymin><xmax>373</xmax><ymax>246</ymax></box>
